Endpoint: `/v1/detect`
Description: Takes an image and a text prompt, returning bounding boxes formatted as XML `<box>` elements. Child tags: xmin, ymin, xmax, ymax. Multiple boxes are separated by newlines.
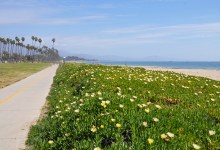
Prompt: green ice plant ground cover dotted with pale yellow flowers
<box><xmin>27</xmin><ymin>64</ymin><xmax>220</xmax><ymax>150</ymax></box>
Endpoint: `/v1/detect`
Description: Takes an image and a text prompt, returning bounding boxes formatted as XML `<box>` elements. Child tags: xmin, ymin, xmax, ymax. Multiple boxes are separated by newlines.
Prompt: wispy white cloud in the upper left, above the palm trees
<box><xmin>0</xmin><ymin>0</ymin><xmax>107</xmax><ymax>25</ymax></box>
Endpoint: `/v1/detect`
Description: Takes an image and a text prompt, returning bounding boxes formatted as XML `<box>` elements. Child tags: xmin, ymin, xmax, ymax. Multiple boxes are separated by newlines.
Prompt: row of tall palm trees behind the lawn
<box><xmin>0</xmin><ymin>36</ymin><xmax>60</xmax><ymax>63</ymax></box>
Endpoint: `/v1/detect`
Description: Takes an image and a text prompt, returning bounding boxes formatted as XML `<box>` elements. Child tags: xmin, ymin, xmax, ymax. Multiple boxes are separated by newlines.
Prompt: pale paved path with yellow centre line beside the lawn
<box><xmin>0</xmin><ymin>65</ymin><xmax>58</xmax><ymax>150</ymax></box>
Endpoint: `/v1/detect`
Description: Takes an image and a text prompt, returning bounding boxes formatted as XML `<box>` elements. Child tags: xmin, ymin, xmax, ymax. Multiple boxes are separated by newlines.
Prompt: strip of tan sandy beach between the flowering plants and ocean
<box><xmin>140</xmin><ymin>66</ymin><xmax>220</xmax><ymax>81</ymax></box>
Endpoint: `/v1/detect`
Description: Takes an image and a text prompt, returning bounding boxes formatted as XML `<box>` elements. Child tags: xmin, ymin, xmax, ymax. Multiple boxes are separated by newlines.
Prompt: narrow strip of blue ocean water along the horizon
<box><xmin>87</xmin><ymin>61</ymin><xmax>220</xmax><ymax>70</ymax></box>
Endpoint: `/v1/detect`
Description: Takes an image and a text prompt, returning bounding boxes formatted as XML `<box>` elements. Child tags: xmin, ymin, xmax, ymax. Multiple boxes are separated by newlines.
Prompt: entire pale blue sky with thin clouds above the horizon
<box><xmin>0</xmin><ymin>0</ymin><xmax>220</xmax><ymax>61</ymax></box>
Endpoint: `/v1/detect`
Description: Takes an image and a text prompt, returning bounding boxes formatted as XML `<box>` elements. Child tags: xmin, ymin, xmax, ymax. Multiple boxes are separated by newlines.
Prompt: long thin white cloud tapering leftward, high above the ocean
<box><xmin>102</xmin><ymin>22</ymin><xmax>220</xmax><ymax>38</ymax></box>
